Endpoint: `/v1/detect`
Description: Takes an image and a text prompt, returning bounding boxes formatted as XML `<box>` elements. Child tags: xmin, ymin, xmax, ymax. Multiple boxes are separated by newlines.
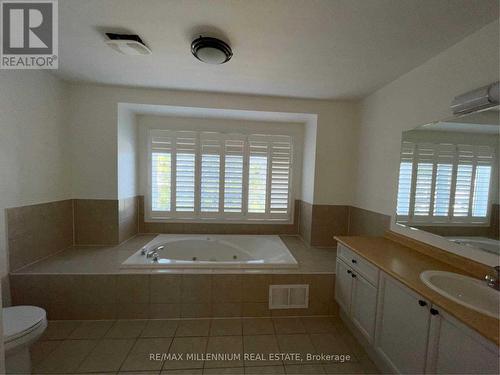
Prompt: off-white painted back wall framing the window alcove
<box><xmin>70</xmin><ymin>84</ymin><xmax>358</xmax><ymax>204</ymax></box>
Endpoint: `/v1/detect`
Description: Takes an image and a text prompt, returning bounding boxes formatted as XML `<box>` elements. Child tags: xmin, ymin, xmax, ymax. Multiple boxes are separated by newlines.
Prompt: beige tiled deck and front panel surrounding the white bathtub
<box><xmin>10</xmin><ymin>235</ymin><xmax>337</xmax><ymax>319</ymax></box>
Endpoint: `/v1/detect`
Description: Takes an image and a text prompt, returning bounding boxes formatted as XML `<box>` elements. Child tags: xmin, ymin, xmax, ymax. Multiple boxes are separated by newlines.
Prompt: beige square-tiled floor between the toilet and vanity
<box><xmin>28</xmin><ymin>317</ymin><xmax>378</xmax><ymax>374</ymax></box>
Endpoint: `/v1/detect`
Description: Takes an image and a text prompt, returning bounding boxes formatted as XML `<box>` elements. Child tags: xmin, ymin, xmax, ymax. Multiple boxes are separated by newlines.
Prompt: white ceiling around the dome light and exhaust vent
<box><xmin>56</xmin><ymin>0</ymin><xmax>499</xmax><ymax>99</ymax></box>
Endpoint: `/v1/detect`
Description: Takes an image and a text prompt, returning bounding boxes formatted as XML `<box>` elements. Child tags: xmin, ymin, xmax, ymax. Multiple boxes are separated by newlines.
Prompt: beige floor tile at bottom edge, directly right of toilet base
<box><xmin>33</xmin><ymin>340</ymin><xmax>97</xmax><ymax>374</ymax></box>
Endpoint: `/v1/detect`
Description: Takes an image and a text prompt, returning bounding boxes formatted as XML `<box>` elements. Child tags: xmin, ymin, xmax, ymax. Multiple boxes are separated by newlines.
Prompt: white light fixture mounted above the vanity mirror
<box><xmin>451</xmin><ymin>82</ymin><xmax>500</xmax><ymax>115</ymax></box>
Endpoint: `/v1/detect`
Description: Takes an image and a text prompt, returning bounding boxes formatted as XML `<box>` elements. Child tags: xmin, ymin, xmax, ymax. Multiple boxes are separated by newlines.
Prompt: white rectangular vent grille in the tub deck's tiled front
<box><xmin>269</xmin><ymin>284</ymin><xmax>309</xmax><ymax>309</ymax></box>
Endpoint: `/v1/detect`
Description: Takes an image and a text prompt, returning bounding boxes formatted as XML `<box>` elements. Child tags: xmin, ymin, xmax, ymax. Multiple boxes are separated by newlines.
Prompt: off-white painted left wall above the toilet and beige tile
<box><xmin>0</xmin><ymin>70</ymin><xmax>71</xmax><ymax>277</ymax></box>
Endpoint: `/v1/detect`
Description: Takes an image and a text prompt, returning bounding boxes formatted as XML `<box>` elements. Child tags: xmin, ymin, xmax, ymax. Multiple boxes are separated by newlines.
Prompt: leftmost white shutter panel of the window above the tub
<box><xmin>150</xmin><ymin>131</ymin><xmax>173</xmax><ymax>211</ymax></box>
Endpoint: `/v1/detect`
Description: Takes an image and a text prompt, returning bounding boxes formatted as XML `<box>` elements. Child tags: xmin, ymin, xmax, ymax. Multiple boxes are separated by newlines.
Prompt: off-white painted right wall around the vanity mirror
<box><xmin>354</xmin><ymin>21</ymin><xmax>499</xmax><ymax>264</ymax></box>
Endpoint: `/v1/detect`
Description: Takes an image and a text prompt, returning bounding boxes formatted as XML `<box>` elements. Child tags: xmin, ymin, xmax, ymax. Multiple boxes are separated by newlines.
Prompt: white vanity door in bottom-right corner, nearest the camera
<box><xmin>427</xmin><ymin>306</ymin><xmax>500</xmax><ymax>374</ymax></box>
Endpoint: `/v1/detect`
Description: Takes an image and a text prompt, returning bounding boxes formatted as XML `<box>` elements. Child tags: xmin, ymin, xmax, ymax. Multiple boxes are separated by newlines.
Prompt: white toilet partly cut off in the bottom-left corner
<box><xmin>2</xmin><ymin>306</ymin><xmax>47</xmax><ymax>373</ymax></box>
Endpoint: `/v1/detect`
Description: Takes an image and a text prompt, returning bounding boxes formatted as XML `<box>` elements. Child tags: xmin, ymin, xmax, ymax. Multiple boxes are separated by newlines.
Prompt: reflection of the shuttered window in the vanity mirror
<box><xmin>396</xmin><ymin>142</ymin><xmax>494</xmax><ymax>224</ymax></box>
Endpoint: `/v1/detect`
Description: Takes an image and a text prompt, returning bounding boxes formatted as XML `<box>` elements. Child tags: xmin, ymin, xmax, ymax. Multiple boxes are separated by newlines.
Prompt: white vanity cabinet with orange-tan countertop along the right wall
<box><xmin>335</xmin><ymin>237</ymin><xmax>500</xmax><ymax>374</ymax></box>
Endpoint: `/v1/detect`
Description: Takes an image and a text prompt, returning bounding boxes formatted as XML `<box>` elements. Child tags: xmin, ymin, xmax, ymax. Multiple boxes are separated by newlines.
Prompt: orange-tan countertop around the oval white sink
<box><xmin>335</xmin><ymin>236</ymin><xmax>500</xmax><ymax>345</ymax></box>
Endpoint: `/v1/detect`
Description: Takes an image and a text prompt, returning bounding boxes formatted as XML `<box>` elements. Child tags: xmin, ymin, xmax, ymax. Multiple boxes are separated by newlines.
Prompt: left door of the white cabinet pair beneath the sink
<box><xmin>375</xmin><ymin>273</ymin><xmax>430</xmax><ymax>374</ymax></box>
